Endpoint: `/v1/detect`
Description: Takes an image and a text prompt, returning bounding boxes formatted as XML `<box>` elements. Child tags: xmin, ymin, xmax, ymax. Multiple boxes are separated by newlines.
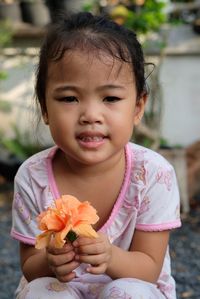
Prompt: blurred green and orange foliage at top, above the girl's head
<box><xmin>84</xmin><ymin>0</ymin><xmax>167</xmax><ymax>33</ymax></box>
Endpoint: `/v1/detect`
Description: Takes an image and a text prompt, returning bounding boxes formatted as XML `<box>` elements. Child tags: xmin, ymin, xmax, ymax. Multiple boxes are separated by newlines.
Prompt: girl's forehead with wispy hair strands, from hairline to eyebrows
<box><xmin>48</xmin><ymin>49</ymin><xmax>134</xmax><ymax>80</ymax></box>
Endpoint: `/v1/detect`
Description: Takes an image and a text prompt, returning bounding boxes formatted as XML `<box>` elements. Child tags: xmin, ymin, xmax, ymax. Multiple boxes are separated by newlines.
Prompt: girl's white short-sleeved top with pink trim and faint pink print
<box><xmin>11</xmin><ymin>143</ymin><xmax>181</xmax><ymax>299</ymax></box>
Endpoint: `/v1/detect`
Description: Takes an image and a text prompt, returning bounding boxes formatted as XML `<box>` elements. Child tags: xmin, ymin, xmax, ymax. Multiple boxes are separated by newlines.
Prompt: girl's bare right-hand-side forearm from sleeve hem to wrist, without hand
<box><xmin>106</xmin><ymin>230</ymin><xmax>169</xmax><ymax>283</ymax></box>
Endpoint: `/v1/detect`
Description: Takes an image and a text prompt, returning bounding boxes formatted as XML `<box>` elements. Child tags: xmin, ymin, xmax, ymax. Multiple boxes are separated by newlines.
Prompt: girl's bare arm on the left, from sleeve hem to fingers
<box><xmin>20</xmin><ymin>243</ymin><xmax>79</xmax><ymax>282</ymax></box>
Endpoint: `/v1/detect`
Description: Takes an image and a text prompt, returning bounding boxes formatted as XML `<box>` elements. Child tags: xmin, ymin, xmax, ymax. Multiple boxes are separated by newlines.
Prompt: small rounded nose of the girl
<box><xmin>79</xmin><ymin>104</ymin><xmax>103</xmax><ymax>125</ymax></box>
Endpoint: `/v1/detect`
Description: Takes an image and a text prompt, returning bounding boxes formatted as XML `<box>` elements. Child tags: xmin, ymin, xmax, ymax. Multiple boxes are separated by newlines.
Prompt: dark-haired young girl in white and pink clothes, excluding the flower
<box><xmin>11</xmin><ymin>13</ymin><xmax>180</xmax><ymax>299</ymax></box>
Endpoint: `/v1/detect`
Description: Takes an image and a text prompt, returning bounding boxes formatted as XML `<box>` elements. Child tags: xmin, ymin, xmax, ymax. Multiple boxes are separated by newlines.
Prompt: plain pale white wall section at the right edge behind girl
<box><xmin>160</xmin><ymin>55</ymin><xmax>200</xmax><ymax>146</ymax></box>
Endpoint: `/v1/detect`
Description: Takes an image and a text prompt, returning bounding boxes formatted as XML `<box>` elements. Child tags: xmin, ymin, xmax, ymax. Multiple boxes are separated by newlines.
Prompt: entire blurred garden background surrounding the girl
<box><xmin>0</xmin><ymin>0</ymin><xmax>200</xmax><ymax>299</ymax></box>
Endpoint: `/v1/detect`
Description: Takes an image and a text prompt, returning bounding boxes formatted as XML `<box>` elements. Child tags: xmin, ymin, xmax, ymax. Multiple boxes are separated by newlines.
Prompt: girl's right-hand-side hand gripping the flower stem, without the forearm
<box><xmin>73</xmin><ymin>233</ymin><xmax>112</xmax><ymax>274</ymax></box>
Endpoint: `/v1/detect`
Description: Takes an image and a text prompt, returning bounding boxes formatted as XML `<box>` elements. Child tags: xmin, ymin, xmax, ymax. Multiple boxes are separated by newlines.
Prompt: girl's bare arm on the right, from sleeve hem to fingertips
<box><xmin>73</xmin><ymin>230</ymin><xmax>169</xmax><ymax>283</ymax></box>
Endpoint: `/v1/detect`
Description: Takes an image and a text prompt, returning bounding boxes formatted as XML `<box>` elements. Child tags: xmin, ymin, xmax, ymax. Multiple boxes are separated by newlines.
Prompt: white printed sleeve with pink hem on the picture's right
<box><xmin>136</xmin><ymin>162</ymin><xmax>181</xmax><ymax>231</ymax></box>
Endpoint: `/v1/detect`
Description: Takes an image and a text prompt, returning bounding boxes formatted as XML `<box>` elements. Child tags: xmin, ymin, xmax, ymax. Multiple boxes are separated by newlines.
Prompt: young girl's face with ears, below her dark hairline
<box><xmin>43</xmin><ymin>50</ymin><xmax>145</xmax><ymax>165</ymax></box>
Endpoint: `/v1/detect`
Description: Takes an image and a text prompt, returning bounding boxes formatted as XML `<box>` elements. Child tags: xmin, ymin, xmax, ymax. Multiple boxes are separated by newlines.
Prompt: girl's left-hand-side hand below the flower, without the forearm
<box><xmin>47</xmin><ymin>243</ymin><xmax>79</xmax><ymax>282</ymax></box>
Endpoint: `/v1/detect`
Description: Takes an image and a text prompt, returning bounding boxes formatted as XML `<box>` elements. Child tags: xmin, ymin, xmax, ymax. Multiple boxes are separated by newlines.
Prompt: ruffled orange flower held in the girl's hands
<box><xmin>35</xmin><ymin>195</ymin><xmax>99</xmax><ymax>249</ymax></box>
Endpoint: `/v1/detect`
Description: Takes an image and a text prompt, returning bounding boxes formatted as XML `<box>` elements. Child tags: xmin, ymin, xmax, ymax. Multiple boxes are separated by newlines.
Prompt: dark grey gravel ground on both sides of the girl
<box><xmin>0</xmin><ymin>193</ymin><xmax>200</xmax><ymax>299</ymax></box>
